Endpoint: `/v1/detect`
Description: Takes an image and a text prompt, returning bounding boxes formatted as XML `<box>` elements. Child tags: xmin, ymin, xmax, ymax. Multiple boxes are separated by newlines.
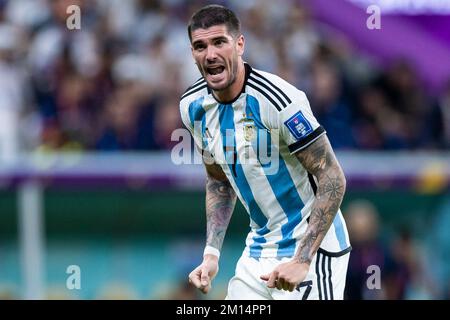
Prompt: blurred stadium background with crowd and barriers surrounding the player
<box><xmin>0</xmin><ymin>0</ymin><xmax>450</xmax><ymax>299</ymax></box>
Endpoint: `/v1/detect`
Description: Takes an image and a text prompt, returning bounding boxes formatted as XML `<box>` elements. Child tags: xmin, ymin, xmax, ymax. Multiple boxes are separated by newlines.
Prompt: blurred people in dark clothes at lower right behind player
<box><xmin>345</xmin><ymin>200</ymin><xmax>440</xmax><ymax>300</ymax></box>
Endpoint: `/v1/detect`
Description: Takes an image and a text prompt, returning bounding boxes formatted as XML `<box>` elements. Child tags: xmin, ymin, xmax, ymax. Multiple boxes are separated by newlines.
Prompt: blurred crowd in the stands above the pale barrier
<box><xmin>0</xmin><ymin>0</ymin><xmax>450</xmax><ymax>156</ymax></box>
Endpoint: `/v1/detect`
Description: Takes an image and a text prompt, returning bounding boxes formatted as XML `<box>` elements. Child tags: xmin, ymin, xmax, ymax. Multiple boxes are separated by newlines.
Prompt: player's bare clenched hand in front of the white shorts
<box><xmin>260</xmin><ymin>260</ymin><xmax>309</xmax><ymax>292</ymax></box>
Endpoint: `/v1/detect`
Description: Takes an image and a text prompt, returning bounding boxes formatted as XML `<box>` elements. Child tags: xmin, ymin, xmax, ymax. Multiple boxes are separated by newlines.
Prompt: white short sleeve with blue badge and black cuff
<box><xmin>278</xmin><ymin>91</ymin><xmax>325</xmax><ymax>154</ymax></box>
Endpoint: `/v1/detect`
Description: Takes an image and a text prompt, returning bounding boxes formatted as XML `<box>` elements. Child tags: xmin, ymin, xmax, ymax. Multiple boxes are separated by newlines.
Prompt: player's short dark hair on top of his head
<box><xmin>188</xmin><ymin>4</ymin><xmax>241</xmax><ymax>41</ymax></box>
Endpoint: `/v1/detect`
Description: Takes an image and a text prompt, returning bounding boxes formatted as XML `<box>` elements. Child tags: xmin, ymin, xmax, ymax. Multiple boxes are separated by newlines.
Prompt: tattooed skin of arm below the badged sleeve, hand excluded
<box><xmin>296</xmin><ymin>135</ymin><xmax>346</xmax><ymax>263</ymax></box>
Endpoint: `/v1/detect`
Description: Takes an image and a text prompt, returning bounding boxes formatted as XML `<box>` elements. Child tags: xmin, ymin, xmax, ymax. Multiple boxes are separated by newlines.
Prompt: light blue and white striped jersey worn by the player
<box><xmin>180</xmin><ymin>64</ymin><xmax>350</xmax><ymax>258</ymax></box>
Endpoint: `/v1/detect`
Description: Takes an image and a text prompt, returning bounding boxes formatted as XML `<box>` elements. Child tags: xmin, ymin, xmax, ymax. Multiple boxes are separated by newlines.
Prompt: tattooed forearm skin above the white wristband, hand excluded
<box><xmin>206</xmin><ymin>168</ymin><xmax>236</xmax><ymax>250</ymax></box>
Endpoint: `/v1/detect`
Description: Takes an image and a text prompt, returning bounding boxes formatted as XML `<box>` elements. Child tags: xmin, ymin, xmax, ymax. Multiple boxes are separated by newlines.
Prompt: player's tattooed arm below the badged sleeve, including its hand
<box><xmin>261</xmin><ymin>135</ymin><xmax>346</xmax><ymax>291</ymax></box>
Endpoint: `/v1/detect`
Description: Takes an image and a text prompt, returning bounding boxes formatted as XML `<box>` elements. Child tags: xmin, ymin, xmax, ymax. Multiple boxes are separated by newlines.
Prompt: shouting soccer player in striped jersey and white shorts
<box><xmin>180</xmin><ymin>5</ymin><xmax>351</xmax><ymax>300</ymax></box>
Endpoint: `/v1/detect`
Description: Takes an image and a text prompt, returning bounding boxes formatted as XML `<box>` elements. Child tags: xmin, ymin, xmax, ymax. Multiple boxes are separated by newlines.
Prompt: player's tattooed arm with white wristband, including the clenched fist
<box><xmin>189</xmin><ymin>164</ymin><xmax>236</xmax><ymax>293</ymax></box>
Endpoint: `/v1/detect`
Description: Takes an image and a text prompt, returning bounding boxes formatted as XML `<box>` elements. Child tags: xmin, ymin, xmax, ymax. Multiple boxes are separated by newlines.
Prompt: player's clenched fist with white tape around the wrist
<box><xmin>189</xmin><ymin>254</ymin><xmax>219</xmax><ymax>294</ymax></box>
